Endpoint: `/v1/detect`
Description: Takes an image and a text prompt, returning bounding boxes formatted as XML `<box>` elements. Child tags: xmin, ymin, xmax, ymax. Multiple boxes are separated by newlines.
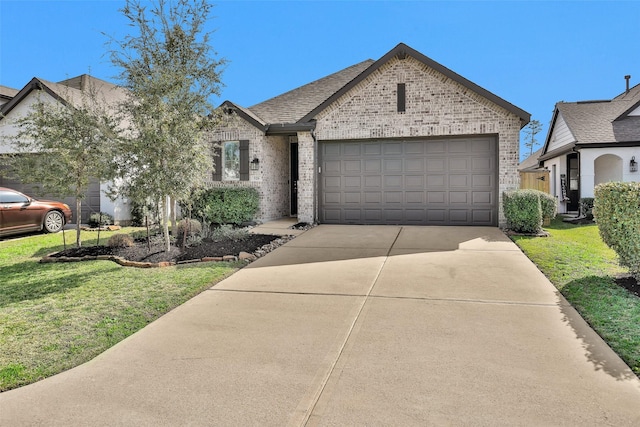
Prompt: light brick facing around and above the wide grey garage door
<box><xmin>298</xmin><ymin>57</ymin><xmax>520</xmax><ymax>225</ymax></box>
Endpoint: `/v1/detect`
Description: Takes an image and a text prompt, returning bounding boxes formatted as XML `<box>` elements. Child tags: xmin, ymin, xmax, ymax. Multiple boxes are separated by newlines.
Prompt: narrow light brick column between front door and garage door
<box><xmin>298</xmin><ymin>132</ymin><xmax>316</xmax><ymax>223</ymax></box>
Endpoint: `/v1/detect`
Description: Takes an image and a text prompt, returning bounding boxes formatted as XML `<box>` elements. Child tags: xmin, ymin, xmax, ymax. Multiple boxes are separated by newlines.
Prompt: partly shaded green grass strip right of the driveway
<box><xmin>513</xmin><ymin>219</ymin><xmax>640</xmax><ymax>375</ymax></box>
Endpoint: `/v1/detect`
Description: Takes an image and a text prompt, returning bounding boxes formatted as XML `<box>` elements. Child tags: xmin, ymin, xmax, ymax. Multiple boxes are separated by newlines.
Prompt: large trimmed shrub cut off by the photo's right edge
<box><xmin>593</xmin><ymin>182</ymin><xmax>640</xmax><ymax>281</ymax></box>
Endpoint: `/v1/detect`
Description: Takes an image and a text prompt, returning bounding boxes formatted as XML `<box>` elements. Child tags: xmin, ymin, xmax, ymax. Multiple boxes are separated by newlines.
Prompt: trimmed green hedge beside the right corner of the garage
<box><xmin>502</xmin><ymin>190</ymin><xmax>556</xmax><ymax>234</ymax></box>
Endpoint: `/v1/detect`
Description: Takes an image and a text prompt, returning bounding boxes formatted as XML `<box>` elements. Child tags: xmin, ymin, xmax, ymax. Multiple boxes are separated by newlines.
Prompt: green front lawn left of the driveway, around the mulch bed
<box><xmin>0</xmin><ymin>229</ymin><xmax>239</xmax><ymax>391</ymax></box>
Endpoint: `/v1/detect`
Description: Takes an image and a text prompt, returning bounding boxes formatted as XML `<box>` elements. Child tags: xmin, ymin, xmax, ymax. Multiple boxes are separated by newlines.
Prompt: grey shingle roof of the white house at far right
<box><xmin>556</xmin><ymin>85</ymin><xmax>640</xmax><ymax>144</ymax></box>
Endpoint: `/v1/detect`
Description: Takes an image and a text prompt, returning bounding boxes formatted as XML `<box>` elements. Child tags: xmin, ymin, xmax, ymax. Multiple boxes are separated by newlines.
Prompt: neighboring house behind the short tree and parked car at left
<box><xmin>0</xmin><ymin>74</ymin><xmax>131</xmax><ymax>223</ymax></box>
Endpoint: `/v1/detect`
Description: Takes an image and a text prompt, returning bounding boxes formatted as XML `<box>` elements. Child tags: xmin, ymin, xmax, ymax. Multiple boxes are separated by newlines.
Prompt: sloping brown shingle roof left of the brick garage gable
<box><xmin>249</xmin><ymin>59</ymin><xmax>374</xmax><ymax>123</ymax></box>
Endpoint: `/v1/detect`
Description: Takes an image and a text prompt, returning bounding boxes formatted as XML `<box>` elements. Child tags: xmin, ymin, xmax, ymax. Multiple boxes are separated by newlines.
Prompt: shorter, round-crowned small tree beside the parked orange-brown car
<box><xmin>8</xmin><ymin>80</ymin><xmax>117</xmax><ymax>247</ymax></box>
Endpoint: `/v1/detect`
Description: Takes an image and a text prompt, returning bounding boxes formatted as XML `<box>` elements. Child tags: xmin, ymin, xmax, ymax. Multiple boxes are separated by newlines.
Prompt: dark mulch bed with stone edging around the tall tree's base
<box><xmin>49</xmin><ymin>234</ymin><xmax>279</xmax><ymax>263</ymax></box>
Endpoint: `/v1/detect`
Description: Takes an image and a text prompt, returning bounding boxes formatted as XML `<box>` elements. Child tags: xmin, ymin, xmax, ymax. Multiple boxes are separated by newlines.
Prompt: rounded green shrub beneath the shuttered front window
<box><xmin>181</xmin><ymin>188</ymin><xmax>260</xmax><ymax>225</ymax></box>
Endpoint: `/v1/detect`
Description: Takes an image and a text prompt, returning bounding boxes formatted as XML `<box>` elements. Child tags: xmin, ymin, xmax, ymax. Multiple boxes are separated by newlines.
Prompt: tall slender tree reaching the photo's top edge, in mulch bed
<box><xmin>111</xmin><ymin>0</ymin><xmax>225</xmax><ymax>251</ymax></box>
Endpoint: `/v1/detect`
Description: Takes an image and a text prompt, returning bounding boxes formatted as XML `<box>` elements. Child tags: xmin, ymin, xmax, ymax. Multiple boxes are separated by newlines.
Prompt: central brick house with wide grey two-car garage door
<box><xmin>207</xmin><ymin>43</ymin><xmax>530</xmax><ymax>226</ymax></box>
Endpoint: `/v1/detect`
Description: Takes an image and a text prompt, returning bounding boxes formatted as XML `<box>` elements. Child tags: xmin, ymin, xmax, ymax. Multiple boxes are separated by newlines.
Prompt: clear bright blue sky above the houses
<box><xmin>0</xmin><ymin>0</ymin><xmax>640</xmax><ymax>157</ymax></box>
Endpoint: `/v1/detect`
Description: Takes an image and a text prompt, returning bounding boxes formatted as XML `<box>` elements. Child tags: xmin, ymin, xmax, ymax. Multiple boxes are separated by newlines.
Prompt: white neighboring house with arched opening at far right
<box><xmin>538</xmin><ymin>76</ymin><xmax>640</xmax><ymax>213</ymax></box>
